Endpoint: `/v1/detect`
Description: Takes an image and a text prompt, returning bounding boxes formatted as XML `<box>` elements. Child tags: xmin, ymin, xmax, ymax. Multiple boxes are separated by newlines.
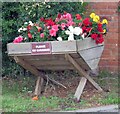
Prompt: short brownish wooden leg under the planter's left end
<box><xmin>34</xmin><ymin>76</ymin><xmax>44</xmax><ymax>96</ymax></box>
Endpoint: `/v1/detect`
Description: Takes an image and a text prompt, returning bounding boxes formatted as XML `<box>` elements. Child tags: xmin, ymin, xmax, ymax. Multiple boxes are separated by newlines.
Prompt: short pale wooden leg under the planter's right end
<box><xmin>74</xmin><ymin>77</ymin><xmax>87</xmax><ymax>101</ymax></box>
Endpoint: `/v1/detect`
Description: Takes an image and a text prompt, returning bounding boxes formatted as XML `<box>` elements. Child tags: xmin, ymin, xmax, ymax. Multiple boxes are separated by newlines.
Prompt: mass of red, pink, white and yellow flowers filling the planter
<box><xmin>13</xmin><ymin>12</ymin><xmax>108</xmax><ymax>44</ymax></box>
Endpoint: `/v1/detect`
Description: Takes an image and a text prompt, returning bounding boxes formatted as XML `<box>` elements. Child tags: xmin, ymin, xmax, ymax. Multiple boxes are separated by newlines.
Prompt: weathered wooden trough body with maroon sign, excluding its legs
<box><xmin>7</xmin><ymin>38</ymin><xmax>104</xmax><ymax>70</ymax></box>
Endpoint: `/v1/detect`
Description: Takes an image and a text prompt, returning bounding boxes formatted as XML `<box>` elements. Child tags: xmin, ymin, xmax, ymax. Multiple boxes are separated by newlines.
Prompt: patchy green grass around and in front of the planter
<box><xmin>0</xmin><ymin>72</ymin><xmax>120</xmax><ymax>112</ymax></box>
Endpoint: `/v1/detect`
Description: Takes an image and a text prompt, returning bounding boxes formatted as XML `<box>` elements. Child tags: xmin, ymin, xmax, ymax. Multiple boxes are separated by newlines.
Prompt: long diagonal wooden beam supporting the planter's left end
<box><xmin>14</xmin><ymin>56</ymin><xmax>67</xmax><ymax>89</ymax></box>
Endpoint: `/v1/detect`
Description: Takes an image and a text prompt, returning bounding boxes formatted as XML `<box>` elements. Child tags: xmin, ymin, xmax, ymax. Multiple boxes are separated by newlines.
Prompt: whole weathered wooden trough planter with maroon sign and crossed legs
<box><xmin>7</xmin><ymin>38</ymin><xmax>104</xmax><ymax>100</ymax></box>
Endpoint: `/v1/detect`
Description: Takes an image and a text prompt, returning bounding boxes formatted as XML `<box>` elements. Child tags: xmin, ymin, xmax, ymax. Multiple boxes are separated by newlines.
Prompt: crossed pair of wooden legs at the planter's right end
<box><xmin>65</xmin><ymin>54</ymin><xmax>103</xmax><ymax>101</ymax></box>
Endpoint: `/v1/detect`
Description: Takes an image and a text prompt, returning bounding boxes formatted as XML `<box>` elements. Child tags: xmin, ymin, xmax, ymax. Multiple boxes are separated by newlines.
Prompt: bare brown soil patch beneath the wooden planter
<box><xmin>43</xmin><ymin>71</ymin><xmax>98</xmax><ymax>99</ymax></box>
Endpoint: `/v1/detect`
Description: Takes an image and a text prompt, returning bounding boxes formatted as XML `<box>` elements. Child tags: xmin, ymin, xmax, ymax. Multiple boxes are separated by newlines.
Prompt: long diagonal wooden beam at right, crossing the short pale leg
<box><xmin>65</xmin><ymin>54</ymin><xmax>103</xmax><ymax>91</ymax></box>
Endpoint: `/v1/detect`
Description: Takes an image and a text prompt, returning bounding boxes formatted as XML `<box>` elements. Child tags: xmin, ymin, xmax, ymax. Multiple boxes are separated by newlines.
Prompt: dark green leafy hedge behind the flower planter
<box><xmin>2</xmin><ymin>2</ymin><xmax>87</xmax><ymax>75</ymax></box>
